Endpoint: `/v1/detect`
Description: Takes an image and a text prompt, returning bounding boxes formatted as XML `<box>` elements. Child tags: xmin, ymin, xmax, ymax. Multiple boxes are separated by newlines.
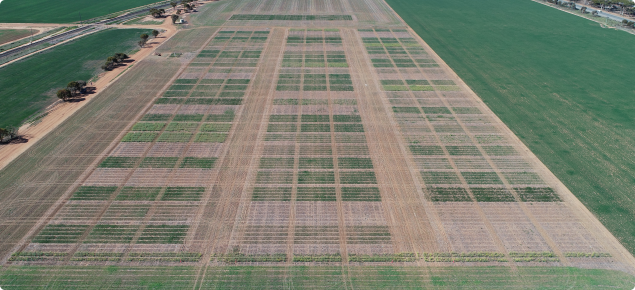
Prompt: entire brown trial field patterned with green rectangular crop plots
<box><xmin>0</xmin><ymin>0</ymin><xmax>635</xmax><ymax>289</ymax></box>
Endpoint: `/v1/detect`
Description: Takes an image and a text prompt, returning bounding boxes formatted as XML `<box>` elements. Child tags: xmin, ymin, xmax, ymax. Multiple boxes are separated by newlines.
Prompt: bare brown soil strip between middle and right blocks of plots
<box><xmin>343</xmin><ymin>30</ymin><xmax>443</xmax><ymax>252</ymax></box>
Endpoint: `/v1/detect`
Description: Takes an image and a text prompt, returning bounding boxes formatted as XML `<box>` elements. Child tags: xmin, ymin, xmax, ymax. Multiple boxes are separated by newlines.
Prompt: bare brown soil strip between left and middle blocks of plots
<box><xmin>191</xmin><ymin>29</ymin><xmax>285</xmax><ymax>286</ymax></box>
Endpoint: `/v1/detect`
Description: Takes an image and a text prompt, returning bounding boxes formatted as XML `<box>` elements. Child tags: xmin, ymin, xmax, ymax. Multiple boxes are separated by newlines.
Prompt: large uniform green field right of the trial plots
<box><xmin>387</xmin><ymin>0</ymin><xmax>635</xmax><ymax>253</ymax></box>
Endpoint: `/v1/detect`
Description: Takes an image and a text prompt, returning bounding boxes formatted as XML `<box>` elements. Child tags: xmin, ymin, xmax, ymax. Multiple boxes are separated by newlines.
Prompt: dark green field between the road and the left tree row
<box><xmin>0</xmin><ymin>29</ymin><xmax>148</xmax><ymax>127</ymax></box>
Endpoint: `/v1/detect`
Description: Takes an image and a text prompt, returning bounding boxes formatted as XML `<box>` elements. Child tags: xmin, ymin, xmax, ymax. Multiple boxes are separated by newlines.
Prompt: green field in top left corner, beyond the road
<box><xmin>0</xmin><ymin>0</ymin><xmax>164</xmax><ymax>23</ymax></box>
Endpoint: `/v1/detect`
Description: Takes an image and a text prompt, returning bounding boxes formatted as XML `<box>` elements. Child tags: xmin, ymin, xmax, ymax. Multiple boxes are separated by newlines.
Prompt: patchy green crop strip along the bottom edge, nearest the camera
<box><xmin>0</xmin><ymin>266</ymin><xmax>635</xmax><ymax>289</ymax></box>
